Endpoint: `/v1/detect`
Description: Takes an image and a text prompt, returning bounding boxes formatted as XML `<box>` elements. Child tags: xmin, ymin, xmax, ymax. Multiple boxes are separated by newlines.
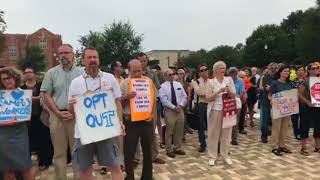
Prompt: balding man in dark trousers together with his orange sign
<box><xmin>121</xmin><ymin>59</ymin><xmax>157</xmax><ymax>180</ymax></box>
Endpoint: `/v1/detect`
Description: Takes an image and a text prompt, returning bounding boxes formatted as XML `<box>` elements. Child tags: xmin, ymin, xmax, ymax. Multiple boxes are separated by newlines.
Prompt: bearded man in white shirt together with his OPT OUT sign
<box><xmin>69</xmin><ymin>48</ymin><xmax>123</xmax><ymax>180</ymax></box>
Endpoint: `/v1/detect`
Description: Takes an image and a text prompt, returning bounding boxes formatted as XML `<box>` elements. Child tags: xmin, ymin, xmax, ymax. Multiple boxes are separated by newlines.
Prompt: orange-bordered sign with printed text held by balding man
<box><xmin>129</xmin><ymin>78</ymin><xmax>154</xmax><ymax>121</ymax></box>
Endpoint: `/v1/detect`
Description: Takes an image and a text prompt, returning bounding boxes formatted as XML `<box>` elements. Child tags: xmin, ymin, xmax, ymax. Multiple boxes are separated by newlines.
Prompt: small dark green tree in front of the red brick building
<box><xmin>17</xmin><ymin>46</ymin><xmax>47</xmax><ymax>72</ymax></box>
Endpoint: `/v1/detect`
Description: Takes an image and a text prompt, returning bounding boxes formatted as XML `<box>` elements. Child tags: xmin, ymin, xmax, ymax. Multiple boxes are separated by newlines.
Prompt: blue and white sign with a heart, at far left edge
<box><xmin>0</xmin><ymin>89</ymin><xmax>32</xmax><ymax>125</ymax></box>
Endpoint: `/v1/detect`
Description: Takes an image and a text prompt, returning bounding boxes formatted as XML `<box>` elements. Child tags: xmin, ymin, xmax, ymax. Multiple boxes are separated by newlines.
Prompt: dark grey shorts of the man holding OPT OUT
<box><xmin>73</xmin><ymin>138</ymin><xmax>121</xmax><ymax>170</ymax></box>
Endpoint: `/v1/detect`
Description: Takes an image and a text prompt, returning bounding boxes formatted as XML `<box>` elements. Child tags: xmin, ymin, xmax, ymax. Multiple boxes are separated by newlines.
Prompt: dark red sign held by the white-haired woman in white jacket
<box><xmin>222</xmin><ymin>93</ymin><xmax>237</xmax><ymax>128</ymax></box>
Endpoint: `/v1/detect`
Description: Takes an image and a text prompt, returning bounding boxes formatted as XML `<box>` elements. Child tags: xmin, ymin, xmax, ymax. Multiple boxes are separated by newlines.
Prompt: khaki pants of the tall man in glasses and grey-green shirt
<box><xmin>50</xmin><ymin>113</ymin><xmax>78</xmax><ymax>180</ymax></box>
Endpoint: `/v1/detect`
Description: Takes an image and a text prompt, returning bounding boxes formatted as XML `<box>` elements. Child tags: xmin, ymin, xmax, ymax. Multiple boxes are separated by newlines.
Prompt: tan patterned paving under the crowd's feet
<box><xmin>37</xmin><ymin>119</ymin><xmax>320</xmax><ymax>180</ymax></box>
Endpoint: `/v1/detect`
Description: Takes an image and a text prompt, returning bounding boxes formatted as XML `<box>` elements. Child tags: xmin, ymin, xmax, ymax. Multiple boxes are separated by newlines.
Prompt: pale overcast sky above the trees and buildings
<box><xmin>0</xmin><ymin>0</ymin><xmax>315</xmax><ymax>51</ymax></box>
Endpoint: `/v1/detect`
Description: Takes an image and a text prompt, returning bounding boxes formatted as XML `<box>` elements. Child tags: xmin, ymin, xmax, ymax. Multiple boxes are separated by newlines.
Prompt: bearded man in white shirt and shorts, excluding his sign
<box><xmin>68</xmin><ymin>48</ymin><xmax>124</xmax><ymax>180</ymax></box>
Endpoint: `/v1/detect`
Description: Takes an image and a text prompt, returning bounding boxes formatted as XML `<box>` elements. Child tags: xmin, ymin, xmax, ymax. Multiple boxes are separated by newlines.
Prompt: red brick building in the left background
<box><xmin>0</xmin><ymin>28</ymin><xmax>62</xmax><ymax>68</ymax></box>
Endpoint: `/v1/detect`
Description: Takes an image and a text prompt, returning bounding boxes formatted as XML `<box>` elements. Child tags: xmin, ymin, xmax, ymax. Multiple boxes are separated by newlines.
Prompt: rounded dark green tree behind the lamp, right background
<box><xmin>243</xmin><ymin>24</ymin><xmax>291</xmax><ymax>66</ymax></box>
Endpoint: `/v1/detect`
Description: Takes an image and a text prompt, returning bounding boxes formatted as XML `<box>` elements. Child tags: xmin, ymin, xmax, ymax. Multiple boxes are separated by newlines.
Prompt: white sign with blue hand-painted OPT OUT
<box><xmin>74</xmin><ymin>91</ymin><xmax>122</xmax><ymax>145</ymax></box>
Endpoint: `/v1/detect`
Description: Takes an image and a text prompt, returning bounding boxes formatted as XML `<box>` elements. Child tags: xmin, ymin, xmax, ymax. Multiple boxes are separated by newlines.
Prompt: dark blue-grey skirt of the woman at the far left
<box><xmin>0</xmin><ymin>123</ymin><xmax>32</xmax><ymax>171</ymax></box>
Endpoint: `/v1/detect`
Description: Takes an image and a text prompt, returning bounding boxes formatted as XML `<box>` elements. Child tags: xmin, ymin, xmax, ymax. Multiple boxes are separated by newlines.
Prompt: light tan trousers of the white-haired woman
<box><xmin>207</xmin><ymin>110</ymin><xmax>232</xmax><ymax>160</ymax></box>
